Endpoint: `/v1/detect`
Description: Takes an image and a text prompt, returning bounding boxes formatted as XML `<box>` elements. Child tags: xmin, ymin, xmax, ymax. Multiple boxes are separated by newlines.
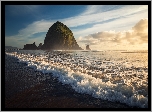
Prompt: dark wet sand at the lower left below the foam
<box><xmin>5</xmin><ymin>55</ymin><xmax>137</xmax><ymax>108</ymax></box>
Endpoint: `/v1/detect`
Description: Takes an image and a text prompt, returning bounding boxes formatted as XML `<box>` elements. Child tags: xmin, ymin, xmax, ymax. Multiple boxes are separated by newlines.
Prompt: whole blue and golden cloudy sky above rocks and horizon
<box><xmin>5</xmin><ymin>5</ymin><xmax>148</xmax><ymax>50</ymax></box>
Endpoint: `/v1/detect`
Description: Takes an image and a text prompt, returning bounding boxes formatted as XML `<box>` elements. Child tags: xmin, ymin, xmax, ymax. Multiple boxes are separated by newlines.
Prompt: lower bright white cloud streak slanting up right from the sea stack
<box><xmin>73</xmin><ymin>8</ymin><xmax>148</xmax><ymax>37</ymax></box>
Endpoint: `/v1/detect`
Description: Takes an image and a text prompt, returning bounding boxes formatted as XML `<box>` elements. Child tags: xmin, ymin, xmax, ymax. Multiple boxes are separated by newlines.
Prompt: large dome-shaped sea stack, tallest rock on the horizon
<box><xmin>42</xmin><ymin>21</ymin><xmax>82</xmax><ymax>50</ymax></box>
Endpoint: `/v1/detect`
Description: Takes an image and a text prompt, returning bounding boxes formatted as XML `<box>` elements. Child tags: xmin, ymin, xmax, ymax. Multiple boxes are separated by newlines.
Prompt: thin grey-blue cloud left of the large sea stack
<box><xmin>5</xmin><ymin>20</ymin><xmax>55</xmax><ymax>48</ymax></box>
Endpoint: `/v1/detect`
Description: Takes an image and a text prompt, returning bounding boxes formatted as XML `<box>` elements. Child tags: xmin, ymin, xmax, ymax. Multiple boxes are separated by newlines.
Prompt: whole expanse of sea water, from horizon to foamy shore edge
<box><xmin>6</xmin><ymin>50</ymin><xmax>148</xmax><ymax>108</ymax></box>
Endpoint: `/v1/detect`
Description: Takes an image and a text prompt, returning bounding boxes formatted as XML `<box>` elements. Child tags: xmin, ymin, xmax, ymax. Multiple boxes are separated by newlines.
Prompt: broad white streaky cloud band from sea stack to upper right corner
<box><xmin>73</xmin><ymin>6</ymin><xmax>148</xmax><ymax>37</ymax></box>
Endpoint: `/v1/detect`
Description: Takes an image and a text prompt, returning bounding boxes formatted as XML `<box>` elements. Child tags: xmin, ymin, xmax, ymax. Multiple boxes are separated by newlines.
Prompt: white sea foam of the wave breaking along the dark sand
<box><xmin>6</xmin><ymin>51</ymin><xmax>148</xmax><ymax>108</ymax></box>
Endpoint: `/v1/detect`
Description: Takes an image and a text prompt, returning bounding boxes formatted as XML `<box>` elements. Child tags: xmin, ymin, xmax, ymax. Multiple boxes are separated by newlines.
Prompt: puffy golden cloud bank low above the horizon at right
<box><xmin>77</xmin><ymin>19</ymin><xmax>148</xmax><ymax>48</ymax></box>
